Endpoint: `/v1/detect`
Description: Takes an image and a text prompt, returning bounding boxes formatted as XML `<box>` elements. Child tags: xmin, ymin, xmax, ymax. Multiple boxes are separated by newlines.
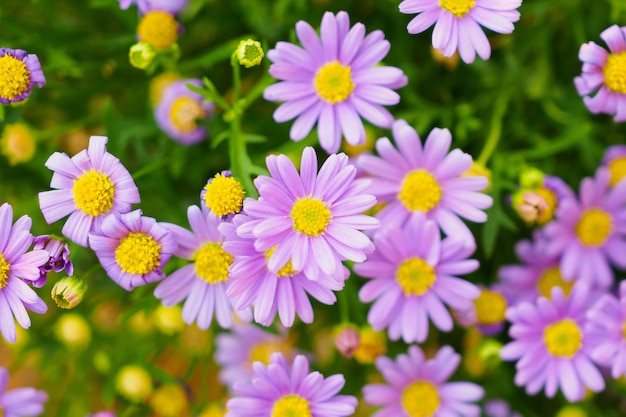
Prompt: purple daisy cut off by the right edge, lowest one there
<box><xmin>586</xmin><ymin>281</ymin><xmax>626</xmax><ymax>379</ymax></box>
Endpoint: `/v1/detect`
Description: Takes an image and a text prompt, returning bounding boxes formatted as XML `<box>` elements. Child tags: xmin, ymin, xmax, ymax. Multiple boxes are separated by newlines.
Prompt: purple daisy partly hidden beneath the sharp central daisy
<box><xmin>220</xmin><ymin>214</ymin><xmax>350</xmax><ymax>327</ymax></box>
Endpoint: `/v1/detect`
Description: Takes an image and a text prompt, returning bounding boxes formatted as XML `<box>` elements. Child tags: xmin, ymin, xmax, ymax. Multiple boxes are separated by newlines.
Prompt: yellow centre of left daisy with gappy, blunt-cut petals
<box><xmin>72</xmin><ymin>168</ymin><xmax>115</xmax><ymax>217</ymax></box>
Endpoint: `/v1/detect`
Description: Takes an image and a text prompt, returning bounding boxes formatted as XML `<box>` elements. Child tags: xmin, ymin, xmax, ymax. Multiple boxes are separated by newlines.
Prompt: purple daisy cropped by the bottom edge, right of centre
<box><xmin>363</xmin><ymin>345</ymin><xmax>484</xmax><ymax>417</ymax></box>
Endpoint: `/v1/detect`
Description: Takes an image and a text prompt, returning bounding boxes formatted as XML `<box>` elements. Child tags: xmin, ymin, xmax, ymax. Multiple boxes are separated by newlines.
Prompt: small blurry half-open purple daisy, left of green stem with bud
<box><xmin>154</xmin><ymin>79</ymin><xmax>215</xmax><ymax>145</ymax></box>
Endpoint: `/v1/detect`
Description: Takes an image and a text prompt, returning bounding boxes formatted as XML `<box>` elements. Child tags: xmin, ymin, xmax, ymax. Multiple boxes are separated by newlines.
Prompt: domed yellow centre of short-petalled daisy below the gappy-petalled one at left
<box><xmin>115</xmin><ymin>232</ymin><xmax>162</xmax><ymax>275</ymax></box>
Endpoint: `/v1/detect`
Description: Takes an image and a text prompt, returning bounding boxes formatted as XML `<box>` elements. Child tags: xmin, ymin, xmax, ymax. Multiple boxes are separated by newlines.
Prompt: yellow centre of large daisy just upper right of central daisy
<box><xmin>398</xmin><ymin>169</ymin><xmax>441</xmax><ymax>213</ymax></box>
